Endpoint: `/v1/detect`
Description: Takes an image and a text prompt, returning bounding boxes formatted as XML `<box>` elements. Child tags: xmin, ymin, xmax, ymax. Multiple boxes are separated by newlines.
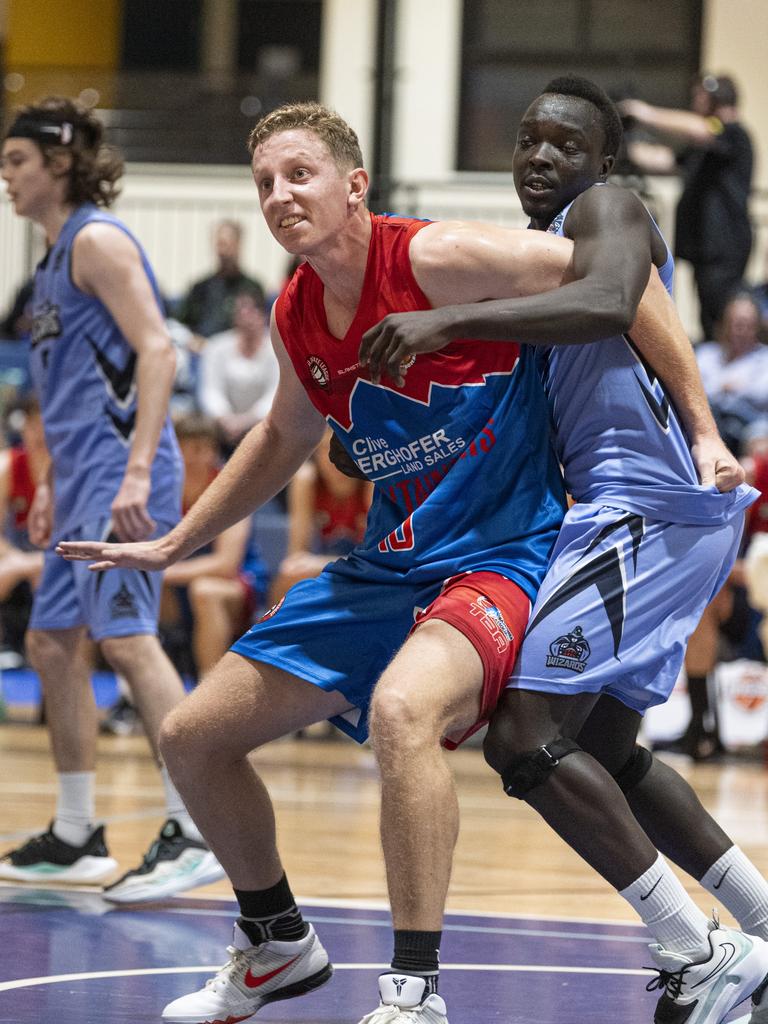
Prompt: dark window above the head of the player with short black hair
<box><xmin>458</xmin><ymin>0</ymin><xmax>701</xmax><ymax>171</ymax></box>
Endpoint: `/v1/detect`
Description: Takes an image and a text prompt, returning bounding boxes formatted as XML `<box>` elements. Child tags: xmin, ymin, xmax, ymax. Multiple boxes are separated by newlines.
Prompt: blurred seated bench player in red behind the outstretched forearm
<box><xmin>160</xmin><ymin>416</ymin><xmax>267</xmax><ymax>675</ymax></box>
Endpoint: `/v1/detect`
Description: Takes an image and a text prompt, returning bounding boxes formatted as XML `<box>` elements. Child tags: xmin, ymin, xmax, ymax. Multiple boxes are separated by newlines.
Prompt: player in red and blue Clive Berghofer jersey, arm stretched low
<box><xmin>58</xmin><ymin>104</ymin><xmax>765</xmax><ymax>1024</ymax></box>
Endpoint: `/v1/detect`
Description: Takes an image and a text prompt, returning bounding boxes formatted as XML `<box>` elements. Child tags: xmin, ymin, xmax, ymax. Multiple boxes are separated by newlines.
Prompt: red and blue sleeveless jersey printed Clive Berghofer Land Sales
<box><xmin>275</xmin><ymin>216</ymin><xmax>564</xmax><ymax>597</ymax></box>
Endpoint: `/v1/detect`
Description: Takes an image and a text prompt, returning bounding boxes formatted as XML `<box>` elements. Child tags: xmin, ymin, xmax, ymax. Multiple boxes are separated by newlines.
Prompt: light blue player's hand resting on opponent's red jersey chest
<box><xmin>359</xmin><ymin>306</ymin><xmax>454</xmax><ymax>387</ymax></box>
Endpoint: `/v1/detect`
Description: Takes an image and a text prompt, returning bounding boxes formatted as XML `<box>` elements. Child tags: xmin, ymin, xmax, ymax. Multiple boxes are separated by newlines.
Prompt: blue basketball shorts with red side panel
<box><xmin>231</xmin><ymin>561</ymin><xmax>530</xmax><ymax>748</ymax></box>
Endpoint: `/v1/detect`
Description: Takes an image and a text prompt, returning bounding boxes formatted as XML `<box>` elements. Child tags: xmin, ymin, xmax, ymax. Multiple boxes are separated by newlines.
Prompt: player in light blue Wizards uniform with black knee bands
<box><xmin>362</xmin><ymin>78</ymin><xmax>768</xmax><ymax>1024</ymax></box>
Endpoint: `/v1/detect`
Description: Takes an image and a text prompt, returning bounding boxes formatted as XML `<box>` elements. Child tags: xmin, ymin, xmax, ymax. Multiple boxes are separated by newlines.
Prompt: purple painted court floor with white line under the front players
<box><xmin>0</xmin><ymin>886</ymin><xmax>749</xmax><ymax>1024</ymax></box>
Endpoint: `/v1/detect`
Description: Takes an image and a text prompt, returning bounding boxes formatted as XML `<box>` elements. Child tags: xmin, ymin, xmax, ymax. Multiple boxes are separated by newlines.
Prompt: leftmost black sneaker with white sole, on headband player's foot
<box><xmin>0</xmin><ymin>822</ymin><xmax>118</xmax><ymax>884</ymax></box>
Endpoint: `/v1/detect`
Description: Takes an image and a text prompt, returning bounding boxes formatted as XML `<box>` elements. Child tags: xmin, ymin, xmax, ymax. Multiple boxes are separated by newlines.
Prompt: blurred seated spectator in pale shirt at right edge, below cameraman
<box><xmin>695</xmin><ymin>291</ymin><xmax>768</xmax><ymax>454</ymax></box>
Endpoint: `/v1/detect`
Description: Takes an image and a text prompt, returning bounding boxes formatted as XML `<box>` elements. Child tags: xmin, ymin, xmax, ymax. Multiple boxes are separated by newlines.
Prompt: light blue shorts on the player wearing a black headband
<box><xmin>29</xmin><ymin>519</ymin><xmax>172</xmax><ymax>641</ymax></box>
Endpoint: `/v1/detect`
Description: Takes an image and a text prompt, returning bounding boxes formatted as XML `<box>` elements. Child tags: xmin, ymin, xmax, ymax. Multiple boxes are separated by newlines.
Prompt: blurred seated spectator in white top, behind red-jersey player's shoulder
<box><xmin>198</xmin><ymin>290</ymin><xmax>280</xmax><ymax>451</ymax></box>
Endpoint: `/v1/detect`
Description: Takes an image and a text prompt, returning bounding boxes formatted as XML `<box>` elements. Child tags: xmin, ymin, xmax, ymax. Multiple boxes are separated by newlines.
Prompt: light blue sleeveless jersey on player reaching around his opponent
<box><xmin>539</xmin><ymin>191</ymin><xmax>754</xmax><ymax>526</ymax></box>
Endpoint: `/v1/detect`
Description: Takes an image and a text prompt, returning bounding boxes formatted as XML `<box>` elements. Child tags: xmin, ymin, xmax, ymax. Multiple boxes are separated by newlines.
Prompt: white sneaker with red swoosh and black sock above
<box><xmin>163</xmin><ymin>923</ymin><xmax>333</xmax><ymax>1024</ymax></box>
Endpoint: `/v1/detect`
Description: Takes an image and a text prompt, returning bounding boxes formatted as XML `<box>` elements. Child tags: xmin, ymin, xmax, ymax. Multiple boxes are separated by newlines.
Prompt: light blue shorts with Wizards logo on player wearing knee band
<box><xmin>509</xmin><ymin>505</ymin><xmax>743</xmax><ymax>714</ymax></box>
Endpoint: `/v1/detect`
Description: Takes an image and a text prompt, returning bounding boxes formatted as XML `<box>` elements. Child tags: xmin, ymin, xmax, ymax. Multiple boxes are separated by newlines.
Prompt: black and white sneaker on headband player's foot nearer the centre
<box><xmin>103</xmin><ymin>818</ymin><xmax>224</xmax><ymax>903</ymax></box>
